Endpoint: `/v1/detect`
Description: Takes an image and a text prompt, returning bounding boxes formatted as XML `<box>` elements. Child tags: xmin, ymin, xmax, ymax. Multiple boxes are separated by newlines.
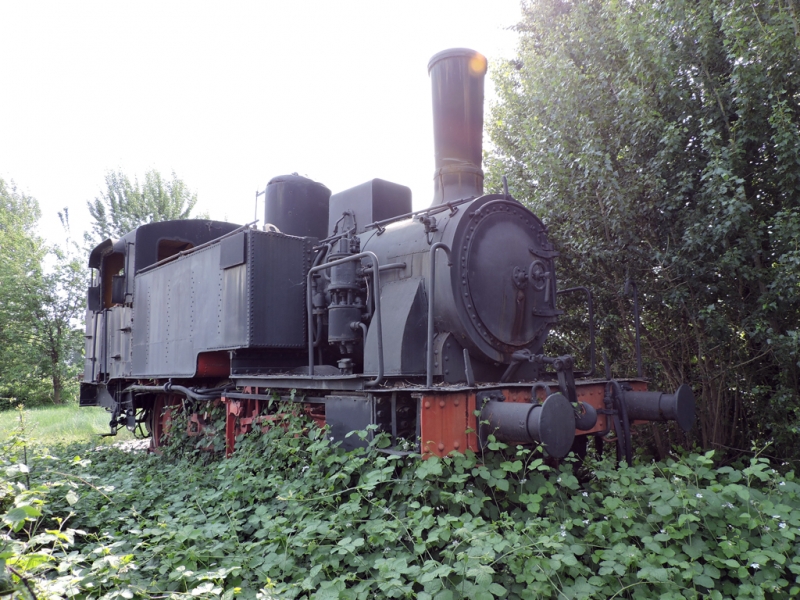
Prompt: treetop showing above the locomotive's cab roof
<box><xmin>86</xmin><ymin>170</ymin><xmax>197</xmax><ymax>243</ymax></box>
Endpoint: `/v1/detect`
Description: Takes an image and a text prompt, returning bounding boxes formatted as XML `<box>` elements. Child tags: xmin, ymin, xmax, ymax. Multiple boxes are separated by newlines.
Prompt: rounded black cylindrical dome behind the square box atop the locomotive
<box><xmin>264</xmin><ymin>174</ymin><xmax>331</xmax><ymax>240</ymax></box>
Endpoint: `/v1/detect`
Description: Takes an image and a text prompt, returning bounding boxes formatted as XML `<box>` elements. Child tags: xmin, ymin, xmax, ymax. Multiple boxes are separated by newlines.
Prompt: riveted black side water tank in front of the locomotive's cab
<box><xmin>130</xmin><ymin>230</ymin><xmax>310</xmax><ymax>377</ymax></box>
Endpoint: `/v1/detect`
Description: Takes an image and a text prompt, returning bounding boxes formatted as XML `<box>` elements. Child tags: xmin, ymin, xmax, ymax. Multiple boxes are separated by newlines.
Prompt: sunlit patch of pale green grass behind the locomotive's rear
<box><xmin>0</xmin><ymin>404</ymin><xmax>134</xmax><ymax>445</ymax></box>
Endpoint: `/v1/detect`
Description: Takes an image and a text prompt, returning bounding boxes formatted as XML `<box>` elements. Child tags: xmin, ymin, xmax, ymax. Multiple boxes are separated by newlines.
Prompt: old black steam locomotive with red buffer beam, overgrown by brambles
<box><xmin>80</xmin><ymin>48</ymin><xmax>694</xmax><ymax>460</ymax></box>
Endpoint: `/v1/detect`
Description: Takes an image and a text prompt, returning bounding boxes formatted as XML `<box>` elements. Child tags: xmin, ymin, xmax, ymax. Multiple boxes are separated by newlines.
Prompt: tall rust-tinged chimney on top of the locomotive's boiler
<box><xmin>428</xmin><ymin>48</ymin><xmax>486</xmax><ymax>205</ymax></box>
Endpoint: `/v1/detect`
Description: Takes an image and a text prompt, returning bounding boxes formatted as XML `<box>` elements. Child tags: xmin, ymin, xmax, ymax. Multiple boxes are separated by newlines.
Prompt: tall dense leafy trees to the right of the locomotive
<box><xmin>488</xmin><ymin>0</ymin><xmax>800</xmax><ymax>456</ymax></box>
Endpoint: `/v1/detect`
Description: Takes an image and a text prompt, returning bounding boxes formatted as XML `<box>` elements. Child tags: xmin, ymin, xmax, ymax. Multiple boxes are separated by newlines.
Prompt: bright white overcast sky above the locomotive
<box><xmin>0</xmin><ymin>0</ymin><xmax>520</xmax><ymax>242</ymax></box>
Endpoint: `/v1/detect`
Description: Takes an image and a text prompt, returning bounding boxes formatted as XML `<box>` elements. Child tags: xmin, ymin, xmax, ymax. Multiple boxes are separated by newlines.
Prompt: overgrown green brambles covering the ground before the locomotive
<box><xmin>0</xmin><ymin>408</ymin><xmax>800</xmax><ymax>600</ymax></box>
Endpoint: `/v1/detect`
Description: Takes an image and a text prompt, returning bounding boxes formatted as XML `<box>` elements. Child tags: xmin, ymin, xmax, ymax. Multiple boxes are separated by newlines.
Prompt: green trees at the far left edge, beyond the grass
<box><xmin>0</xmin><ymin>179</ymin><xmax>86</xmax><ymax>404</ymax></box>
